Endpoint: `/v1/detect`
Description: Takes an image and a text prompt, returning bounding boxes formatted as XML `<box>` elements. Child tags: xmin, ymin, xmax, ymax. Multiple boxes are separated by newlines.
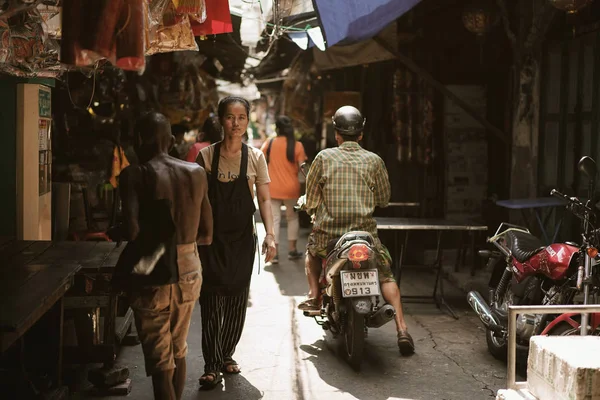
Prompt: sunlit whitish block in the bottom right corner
<box><xmin>527</xmin><ymin>336</ymin><xmax>600</xmax><ymax>400</ymax></box>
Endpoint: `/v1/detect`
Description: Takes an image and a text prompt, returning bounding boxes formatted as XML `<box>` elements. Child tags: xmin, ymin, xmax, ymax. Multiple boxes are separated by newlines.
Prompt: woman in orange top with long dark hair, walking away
<box><xmin>261</xmin><ymin>115</ymin><xmax>306</xmax><ymax>264</ymax></box>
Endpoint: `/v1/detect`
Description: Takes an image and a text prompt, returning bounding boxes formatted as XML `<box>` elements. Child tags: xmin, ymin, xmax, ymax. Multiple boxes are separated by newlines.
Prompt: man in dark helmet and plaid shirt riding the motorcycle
<box><xmin>298</xmin><ymin>106</ymin><xmax>415</xmax><ymax>355</ymax></box>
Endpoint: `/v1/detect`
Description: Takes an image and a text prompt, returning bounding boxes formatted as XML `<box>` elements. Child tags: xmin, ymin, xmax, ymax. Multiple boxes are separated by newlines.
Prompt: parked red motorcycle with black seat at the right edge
<box><xmin>467</xmin><ymin>157</ymin><xmax>600</xmax><ymax>360</ymax></box>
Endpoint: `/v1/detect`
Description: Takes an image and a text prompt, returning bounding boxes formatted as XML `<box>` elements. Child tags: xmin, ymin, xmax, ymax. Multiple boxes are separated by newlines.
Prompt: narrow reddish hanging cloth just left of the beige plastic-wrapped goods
<box><xmin>116</xmin><ymin>0</ymin><xmax>148</xmax><ymax>71</ymax></box>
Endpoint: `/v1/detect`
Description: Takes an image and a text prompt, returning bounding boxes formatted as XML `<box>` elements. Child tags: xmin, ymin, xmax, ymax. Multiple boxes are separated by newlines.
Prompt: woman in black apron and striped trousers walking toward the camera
<box><xmin>197</xmin><ymin>97</ymin><xmax>275</xmax><ymax>389</ymax></box>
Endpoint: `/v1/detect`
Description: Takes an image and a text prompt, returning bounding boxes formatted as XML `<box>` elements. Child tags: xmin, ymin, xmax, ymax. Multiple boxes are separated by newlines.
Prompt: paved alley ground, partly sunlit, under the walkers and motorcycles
<box><xmin>76</xmin><ymin>225</ymin><xmax>506</xmax><ymax>400</ymax></box>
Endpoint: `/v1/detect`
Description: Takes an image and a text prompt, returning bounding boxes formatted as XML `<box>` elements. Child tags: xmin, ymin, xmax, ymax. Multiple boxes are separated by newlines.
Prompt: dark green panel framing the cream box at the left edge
<box><xmin>0</xmin><ymin>76</ymin><xmax>54</xmax><ymax>236</ymax></box>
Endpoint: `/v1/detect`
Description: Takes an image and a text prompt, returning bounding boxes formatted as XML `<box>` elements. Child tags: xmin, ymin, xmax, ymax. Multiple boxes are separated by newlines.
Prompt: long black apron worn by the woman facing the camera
<box><xmin>198</xmin><ymin>143</ymin><xmax>256</xmax><ymax>295</ymax></box>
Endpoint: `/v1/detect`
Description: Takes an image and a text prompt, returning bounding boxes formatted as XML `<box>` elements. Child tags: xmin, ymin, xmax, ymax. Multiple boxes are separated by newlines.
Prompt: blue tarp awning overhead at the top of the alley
<box><xmin>313</xmin><ymin>0</ymin><xmax>420</xmax><ymax>47</ymax></box>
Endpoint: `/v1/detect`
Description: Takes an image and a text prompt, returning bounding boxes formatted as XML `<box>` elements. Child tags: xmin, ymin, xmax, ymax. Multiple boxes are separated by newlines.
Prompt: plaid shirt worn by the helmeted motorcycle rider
<box><xmin>306</xmin><ymin>142</ymin><xmax>390</xmax><ymax>249</ymax></box>
